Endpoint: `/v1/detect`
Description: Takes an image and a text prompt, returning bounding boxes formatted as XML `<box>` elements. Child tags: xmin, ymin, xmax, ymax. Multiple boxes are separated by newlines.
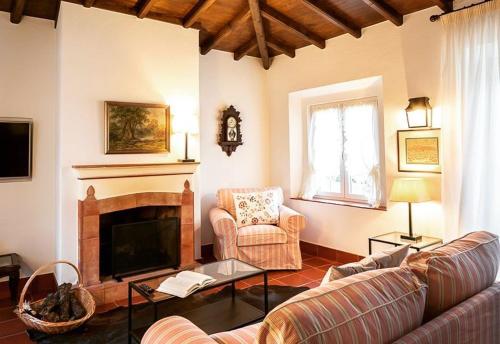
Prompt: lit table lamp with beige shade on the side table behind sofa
<box><xmin>390</xmin><ymin>178</ymin><xmax>431</xmax><ymax>242</ymax></box>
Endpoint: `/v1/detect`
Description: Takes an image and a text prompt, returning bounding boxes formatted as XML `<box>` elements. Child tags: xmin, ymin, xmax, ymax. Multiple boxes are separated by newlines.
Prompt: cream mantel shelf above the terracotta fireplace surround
<box><xmin>72</xmin><ymin>162</ymin><xmax>200</xmax><ymax>180</ymax></box>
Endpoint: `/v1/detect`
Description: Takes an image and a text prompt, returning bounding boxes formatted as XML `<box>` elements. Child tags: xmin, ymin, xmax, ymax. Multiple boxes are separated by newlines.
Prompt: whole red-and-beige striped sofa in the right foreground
<box><xmin>142</xmin><ymin>232</ymin><xmax>500</xmax><ymax>344</ymax></box>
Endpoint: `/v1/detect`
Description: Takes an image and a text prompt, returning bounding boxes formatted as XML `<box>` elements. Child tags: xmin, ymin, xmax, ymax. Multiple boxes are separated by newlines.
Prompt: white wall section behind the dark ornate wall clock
<box><xmin>200</xmin><ymin>51</ymin><xmax>270</xmax><ymax>244</ymax></box>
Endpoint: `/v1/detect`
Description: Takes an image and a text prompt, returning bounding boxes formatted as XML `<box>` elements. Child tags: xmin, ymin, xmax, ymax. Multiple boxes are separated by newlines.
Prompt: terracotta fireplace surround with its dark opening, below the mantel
<box><xmin>78</xmin><ymin>180</ymin><xmax>195</xmax><ymax>304</ymax></box>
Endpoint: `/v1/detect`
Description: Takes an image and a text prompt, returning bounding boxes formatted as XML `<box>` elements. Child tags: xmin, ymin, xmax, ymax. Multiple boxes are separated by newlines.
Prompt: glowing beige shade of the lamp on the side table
<box><xmin>390</xmin><ymin>178</ymin><xmax>431</xmax><ymax>203</ymax></box>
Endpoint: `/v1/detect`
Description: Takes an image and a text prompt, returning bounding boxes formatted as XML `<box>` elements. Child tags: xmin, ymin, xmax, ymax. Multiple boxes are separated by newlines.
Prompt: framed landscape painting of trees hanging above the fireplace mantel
<box><xmin>104</xmin><ymin>102</ymin><xmax>170</xmax><ymax>154</ymax></box>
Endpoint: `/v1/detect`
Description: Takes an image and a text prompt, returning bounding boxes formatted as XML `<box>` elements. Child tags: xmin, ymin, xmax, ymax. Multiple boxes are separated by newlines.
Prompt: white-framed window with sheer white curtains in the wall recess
<box><xmin>305</xmin><ymin>98</ymin><xmax>382</xmax><ymax>206</ymax></box>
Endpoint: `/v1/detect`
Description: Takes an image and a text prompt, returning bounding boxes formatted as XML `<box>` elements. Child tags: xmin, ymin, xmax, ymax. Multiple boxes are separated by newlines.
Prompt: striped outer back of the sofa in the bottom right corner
<box><xmin>395</xmin><ymin>282</ymin><xmax>500</xmax><ymax>344</ymax></box>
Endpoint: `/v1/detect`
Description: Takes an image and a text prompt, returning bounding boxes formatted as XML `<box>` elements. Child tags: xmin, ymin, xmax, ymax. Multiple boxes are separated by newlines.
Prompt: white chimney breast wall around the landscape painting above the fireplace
<box><xmin>57</xmin><ymin>2</ymin><xmax>200</xmax><ymax>272</ymax></box>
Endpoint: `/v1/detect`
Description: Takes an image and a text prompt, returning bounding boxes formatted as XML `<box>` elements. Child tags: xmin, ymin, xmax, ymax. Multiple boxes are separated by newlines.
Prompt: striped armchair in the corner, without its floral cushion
<box><xmin>210</xmin><ymin>187</ymin><xmax>305</xmax><ymax>270</ymax></box>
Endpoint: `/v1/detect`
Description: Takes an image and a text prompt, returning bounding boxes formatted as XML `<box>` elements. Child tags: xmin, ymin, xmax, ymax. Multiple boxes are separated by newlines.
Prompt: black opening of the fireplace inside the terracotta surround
<box><xmin>99</xmin><ymin>207</ymin><xmax>180</xmax><ymax>280</ymax></box>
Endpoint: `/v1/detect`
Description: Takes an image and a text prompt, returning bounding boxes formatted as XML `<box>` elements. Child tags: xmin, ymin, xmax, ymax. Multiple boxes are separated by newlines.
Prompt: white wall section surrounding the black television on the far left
<box><xmin>0</xmin><ymin>12</ymin><xmax>57</xmax><ymax>268</ymax></box>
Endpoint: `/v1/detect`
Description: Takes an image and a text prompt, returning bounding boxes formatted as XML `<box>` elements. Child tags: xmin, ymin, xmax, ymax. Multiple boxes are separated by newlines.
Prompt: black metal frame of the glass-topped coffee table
<box><xmin>128</xmin><ymin>263</ymin><xmax>269</xmax><ymax>344</ymax></box>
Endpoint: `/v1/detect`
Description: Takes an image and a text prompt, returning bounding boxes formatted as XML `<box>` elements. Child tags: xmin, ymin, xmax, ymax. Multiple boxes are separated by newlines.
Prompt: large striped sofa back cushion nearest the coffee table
<box><xmin>256</xmin><ymin>268</ymin><xmax>427</xmax><ymax>344</ymax></box>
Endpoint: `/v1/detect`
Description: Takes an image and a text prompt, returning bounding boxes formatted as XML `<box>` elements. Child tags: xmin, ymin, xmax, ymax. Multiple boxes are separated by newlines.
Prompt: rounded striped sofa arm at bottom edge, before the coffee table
<box><xmin>141</xmin><ymin>316</ymin><xmax>217</xmax><ymax>344</ymax></box>
